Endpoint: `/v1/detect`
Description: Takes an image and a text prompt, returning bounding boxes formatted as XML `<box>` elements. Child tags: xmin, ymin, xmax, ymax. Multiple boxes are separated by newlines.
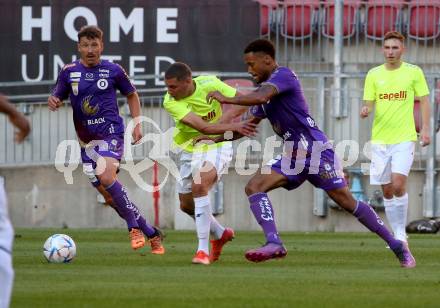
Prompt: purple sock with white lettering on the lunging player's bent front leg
<box><xmin>249</xmin><ymin>193</ymin><xmax>282</xmax><ymax>244</ymax></box>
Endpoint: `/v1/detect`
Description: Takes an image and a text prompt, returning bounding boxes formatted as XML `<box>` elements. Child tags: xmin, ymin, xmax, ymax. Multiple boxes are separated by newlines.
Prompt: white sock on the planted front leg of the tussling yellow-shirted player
<box><xmin>194</xmin><ymin>196</ymin><xmax>211</xmax><ymax>254</ymax></box>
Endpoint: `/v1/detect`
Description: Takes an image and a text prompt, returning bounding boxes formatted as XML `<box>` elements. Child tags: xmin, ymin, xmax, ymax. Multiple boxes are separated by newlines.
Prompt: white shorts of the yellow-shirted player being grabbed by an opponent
<box><xmin>177</xmin><ymin>142</ymin><xmax>233</xmax><ymax>194</ymax></box>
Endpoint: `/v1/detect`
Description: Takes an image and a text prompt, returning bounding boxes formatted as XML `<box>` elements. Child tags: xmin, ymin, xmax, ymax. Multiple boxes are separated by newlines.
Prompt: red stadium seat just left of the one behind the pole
<box><xmin>281</xmin><ymin>0</ymin><xmax>319</xmax><ymax>39</ymax></box>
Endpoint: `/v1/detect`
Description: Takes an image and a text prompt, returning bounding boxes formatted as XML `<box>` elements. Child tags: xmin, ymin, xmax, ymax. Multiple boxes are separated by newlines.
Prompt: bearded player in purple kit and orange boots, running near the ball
<box><xmin>48</xmin><ymin>26</ymin><xmax>165</xmax><ymax>254</ymax></box>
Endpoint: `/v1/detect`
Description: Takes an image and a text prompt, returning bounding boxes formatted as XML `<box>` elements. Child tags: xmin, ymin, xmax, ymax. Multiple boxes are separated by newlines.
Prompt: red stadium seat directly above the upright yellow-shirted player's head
<box><xmin>365</xmin><ymin>0</ymin><xmax>404</xmax><ymax>40</ymax></box>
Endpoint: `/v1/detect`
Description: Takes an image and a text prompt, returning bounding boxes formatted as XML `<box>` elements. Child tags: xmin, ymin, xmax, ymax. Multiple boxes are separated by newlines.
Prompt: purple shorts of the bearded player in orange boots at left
<box><xmin>81</xmin><ymin>136</ymin><xmax>124</xmax><ymax>169</ymax></box>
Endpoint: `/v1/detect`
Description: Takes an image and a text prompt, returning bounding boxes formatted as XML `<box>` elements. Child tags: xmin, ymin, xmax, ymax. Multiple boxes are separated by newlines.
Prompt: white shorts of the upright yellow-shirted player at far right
<box><xmin>370</xmin><ymin>141</ymin><xmax>415</xmax><ymax>185</ymax></box>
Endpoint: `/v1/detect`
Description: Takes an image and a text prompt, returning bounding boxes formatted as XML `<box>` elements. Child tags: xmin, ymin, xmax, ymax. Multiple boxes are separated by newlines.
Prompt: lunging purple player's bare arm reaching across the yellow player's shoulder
<box><xmin>206</xmin><ymin>84</ymin><xmax>278</xmax><ymax>106</ymax></box>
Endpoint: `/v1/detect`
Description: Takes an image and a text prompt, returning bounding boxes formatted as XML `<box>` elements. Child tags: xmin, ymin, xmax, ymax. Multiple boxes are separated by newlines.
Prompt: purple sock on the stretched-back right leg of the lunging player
<box><xmin>353</xmin><ymin>201</ymin><xmax>401</xmax><ymax>250</ymax></box>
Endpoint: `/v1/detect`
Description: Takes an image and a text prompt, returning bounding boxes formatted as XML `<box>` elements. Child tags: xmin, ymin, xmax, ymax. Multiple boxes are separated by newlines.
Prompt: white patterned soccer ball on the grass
<box><xmin>43</xmin><ymin>234</ymin><xmax>76</xmax><ymax>263</ymax></box>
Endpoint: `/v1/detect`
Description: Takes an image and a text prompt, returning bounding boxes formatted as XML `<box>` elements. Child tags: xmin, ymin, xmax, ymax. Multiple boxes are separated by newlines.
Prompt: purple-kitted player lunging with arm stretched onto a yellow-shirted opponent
<box><xmin>207</xmin><ymin>39</ymin><xmax>416</xmax><ymax>267</ymax></box>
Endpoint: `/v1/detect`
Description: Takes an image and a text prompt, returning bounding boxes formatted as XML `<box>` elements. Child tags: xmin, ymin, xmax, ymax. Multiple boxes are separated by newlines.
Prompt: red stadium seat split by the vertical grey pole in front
<box><xmin>322</xmin><ymin>0</ymin><xmax>361</xmax><ymax>38</ymax></box>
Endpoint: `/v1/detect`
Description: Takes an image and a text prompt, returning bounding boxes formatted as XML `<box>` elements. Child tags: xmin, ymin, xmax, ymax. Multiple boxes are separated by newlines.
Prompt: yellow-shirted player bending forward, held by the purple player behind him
<box><xmin>163</xmin><ymin>62</ymin><xmax>255</xmax><ymax>265</ymax></box>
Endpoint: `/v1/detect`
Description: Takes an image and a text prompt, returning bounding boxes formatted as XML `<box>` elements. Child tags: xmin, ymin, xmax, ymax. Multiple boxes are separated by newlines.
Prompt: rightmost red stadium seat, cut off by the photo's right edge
<box><xmin>408</xmin><ymin>0</ymin><xmax>440</xmax><ymax>40</ymax></box>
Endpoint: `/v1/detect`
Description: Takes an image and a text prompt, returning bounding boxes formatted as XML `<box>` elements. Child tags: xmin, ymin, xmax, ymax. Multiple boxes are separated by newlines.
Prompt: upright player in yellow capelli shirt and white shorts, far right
<box><xmin>361</xmin><ymin>32</ymin><xmax>431</xmax><ymax>242</ymax></box>
